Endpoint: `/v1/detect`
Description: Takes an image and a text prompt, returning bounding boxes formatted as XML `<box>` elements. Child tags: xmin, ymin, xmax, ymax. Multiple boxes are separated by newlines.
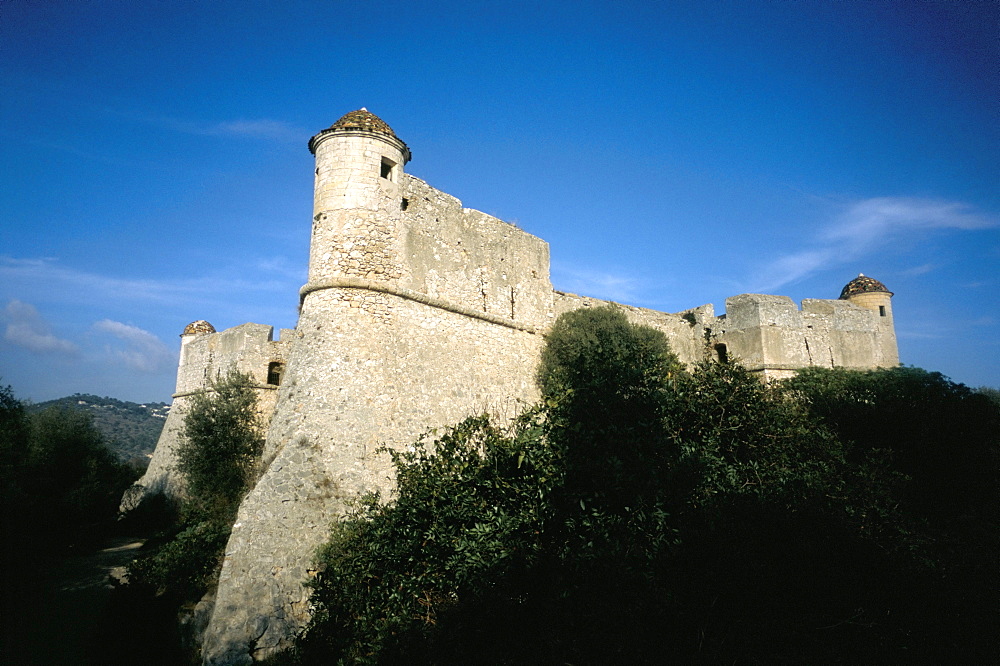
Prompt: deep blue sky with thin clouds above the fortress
<box><xmin>0</xmin><ymin>0</ymin><xmax>1000</xmax><ymax>401</ymax></box>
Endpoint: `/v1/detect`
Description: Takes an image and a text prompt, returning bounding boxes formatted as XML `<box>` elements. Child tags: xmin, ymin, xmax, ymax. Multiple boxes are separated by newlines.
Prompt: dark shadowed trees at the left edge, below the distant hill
<box><xmin>0</xmin><ymin>387</ymin><xmax>135</xmax><ymax>663</ymax></box>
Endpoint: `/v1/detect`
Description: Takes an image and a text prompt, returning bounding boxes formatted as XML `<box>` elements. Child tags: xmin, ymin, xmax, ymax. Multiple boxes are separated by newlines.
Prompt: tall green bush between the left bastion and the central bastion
<box><xmin>105</xmin><ymin>371</ymin><xmax>264</xmax><ymax>664</ymax></box>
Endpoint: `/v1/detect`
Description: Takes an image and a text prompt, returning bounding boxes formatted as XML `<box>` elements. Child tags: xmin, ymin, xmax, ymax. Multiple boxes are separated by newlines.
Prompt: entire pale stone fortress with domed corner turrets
<box><xmin>123</xmin><ymin>109</ymin><xmax>899</xmax><ymax>664</ymax></box>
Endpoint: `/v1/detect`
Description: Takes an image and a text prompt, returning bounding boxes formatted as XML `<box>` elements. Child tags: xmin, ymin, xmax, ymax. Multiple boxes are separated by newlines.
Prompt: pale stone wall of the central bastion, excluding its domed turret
<box><xmin>203</xmin><ymin>174</ymin><xmax>553</xmax><ymax>664</ymax></box>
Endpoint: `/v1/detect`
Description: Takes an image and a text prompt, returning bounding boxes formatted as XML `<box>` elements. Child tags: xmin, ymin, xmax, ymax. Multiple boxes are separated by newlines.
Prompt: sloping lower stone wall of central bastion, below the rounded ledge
<box><xmin>205</xmin><ymin>289</ymin><xmax>543</xmax><ymax>663</ymax></box>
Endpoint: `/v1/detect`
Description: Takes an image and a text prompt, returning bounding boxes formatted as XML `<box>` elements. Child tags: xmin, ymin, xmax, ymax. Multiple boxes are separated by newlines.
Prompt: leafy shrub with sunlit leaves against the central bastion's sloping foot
<box><xmin>304</xmin><ymin>414</ymin><xmax>559</xmax><ymax>663</ymax></box>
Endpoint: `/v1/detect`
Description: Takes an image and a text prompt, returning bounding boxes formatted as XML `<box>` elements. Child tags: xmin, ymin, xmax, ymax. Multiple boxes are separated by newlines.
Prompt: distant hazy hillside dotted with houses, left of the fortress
<box><xmin>28</xmin><ymin>393</ymin><xmax>170</xmax><ymax>465</ymax></box>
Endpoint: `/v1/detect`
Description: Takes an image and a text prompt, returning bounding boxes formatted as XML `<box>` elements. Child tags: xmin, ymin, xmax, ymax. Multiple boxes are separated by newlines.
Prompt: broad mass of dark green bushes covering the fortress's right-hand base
<box><xmin>292</xmin><ymin>309</ymin><xmax>998</xmax><ymax>664</ymax></box>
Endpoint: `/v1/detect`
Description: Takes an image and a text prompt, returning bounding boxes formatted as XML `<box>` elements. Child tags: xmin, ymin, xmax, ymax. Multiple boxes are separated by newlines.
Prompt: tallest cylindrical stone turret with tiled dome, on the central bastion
<box><xmin>309</xmin><ymin>109</ymin><xmax>410</xmax><ymax>283</ymax></box>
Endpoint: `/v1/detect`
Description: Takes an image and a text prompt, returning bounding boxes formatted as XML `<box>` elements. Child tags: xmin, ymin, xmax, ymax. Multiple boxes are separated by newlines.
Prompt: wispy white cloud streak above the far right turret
<box><xmin>757</xmin><ymin>197</ymin><xmax>998</xmax><ymax>291</ymax></box>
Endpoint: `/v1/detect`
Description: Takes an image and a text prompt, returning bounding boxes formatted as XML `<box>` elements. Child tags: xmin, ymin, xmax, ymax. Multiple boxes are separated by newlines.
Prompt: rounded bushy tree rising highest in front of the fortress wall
<box><xmin>538</xmin><ymin>307</ymin><xmax>684</xmax><ymax>506</ymax></box>
